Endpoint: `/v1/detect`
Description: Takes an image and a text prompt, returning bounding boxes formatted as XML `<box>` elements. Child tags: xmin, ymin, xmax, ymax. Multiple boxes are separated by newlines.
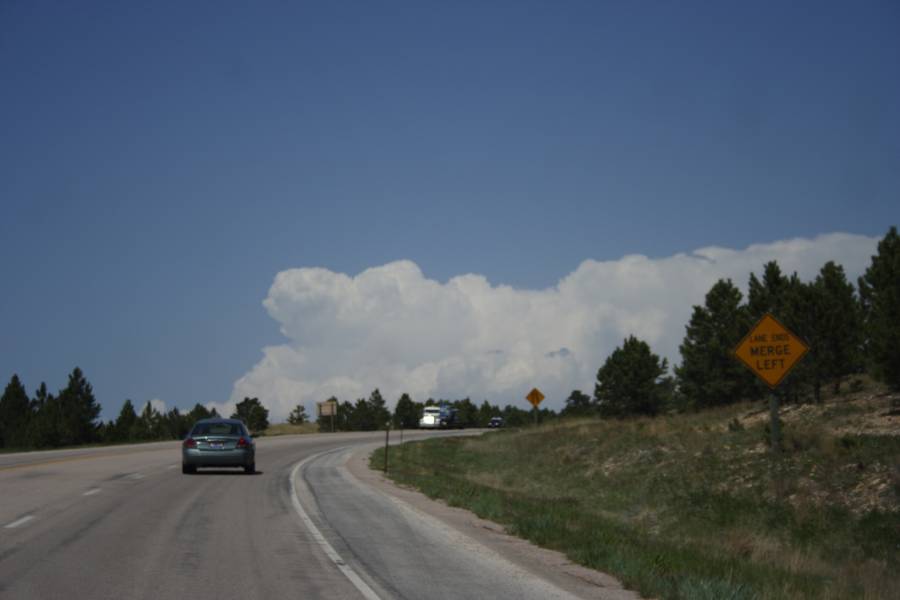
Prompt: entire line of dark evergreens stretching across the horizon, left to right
<box><xmin>0</xmin><ymin>227</ymin><xmax>900</xmax><ymax>448</ymax></box>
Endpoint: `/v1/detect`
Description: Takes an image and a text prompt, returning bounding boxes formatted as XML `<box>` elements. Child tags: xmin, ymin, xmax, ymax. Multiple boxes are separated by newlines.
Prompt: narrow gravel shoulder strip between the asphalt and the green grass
<box><xmin>346</xmin><ymin>445</ymin><xmax>640</xmax><ymax>600</ymax></box>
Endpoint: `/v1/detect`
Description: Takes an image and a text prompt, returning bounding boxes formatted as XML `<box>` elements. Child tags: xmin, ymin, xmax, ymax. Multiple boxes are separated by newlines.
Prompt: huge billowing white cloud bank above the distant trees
<box><xmin>217</xmin><ymin>233</ymin><xmax>877</xmax><ymax>422</ymax></box>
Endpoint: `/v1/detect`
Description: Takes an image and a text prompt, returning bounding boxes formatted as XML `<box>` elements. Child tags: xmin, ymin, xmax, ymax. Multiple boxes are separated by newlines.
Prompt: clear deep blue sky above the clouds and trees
<box><xmin>0</xmin><ymin>1</ymin><xmax>900</xmax><ymax>418</ymax></box>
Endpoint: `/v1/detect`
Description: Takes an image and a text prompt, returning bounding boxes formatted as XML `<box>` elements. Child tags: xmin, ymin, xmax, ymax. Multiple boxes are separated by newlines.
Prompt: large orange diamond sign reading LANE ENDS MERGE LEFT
<box><xmin>734</xmin><ymin>313</ymin><xmax>809</xmax><ymax>389</ymax></box>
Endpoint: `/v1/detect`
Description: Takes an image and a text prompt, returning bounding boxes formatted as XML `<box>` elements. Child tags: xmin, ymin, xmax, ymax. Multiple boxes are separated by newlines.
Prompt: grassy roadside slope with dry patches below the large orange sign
<box><xmin>371</xmin><ymin>396</ymin><xmax>900</xmax><ymax>599</ymax></box>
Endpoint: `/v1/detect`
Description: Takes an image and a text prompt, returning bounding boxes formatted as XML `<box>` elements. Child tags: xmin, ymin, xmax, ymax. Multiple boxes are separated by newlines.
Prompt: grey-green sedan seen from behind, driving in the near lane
<box><xmin>181</xmin><ymin>418</ymin><xmax>256</xmax><ymax>474</ymax></box>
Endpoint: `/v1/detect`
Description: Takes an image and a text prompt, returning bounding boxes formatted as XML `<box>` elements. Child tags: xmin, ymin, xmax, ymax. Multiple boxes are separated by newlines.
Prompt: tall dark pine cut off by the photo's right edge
<box><xmin>859</xmin><ymin>227</ymin><xmax>900</xmax><ymax>390</ymax></box>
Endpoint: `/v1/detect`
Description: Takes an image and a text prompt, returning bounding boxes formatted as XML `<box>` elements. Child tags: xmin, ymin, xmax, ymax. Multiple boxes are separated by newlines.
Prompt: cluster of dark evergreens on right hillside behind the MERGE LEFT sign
<box><xmin>560</xmin><ymin>227</ymin><xmax>900</xmax><ymax>417</ymax></box>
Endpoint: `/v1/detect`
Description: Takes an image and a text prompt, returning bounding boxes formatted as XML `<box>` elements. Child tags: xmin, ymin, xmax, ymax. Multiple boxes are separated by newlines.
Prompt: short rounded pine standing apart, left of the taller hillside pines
<box><xmin>594</xmin><ymin>336</ymin><xmax>666</xmax><ymax>417</ymax></box>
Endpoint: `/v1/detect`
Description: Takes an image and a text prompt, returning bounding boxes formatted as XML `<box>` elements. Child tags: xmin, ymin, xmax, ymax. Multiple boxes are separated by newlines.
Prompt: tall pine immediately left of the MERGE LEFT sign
<box><xmin>675</xmin><ymin>279</ymin><xmax>755</xmax><ymax>408</ymax></box>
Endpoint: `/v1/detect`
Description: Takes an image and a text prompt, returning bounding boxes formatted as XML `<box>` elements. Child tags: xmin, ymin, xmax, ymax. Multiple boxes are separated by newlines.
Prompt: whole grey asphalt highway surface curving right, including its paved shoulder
<box><xmin>0</xmin><ymin>432</ymin><xmax>632</xmax><ymax>600</ymax></box>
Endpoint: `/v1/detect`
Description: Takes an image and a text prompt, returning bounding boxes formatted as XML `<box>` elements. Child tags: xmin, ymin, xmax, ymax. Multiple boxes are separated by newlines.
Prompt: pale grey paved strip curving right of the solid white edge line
<box><xmin>295</xmin><ymin>448</ymin><xmax>596</xmax><ymax>600</ymax></box>
